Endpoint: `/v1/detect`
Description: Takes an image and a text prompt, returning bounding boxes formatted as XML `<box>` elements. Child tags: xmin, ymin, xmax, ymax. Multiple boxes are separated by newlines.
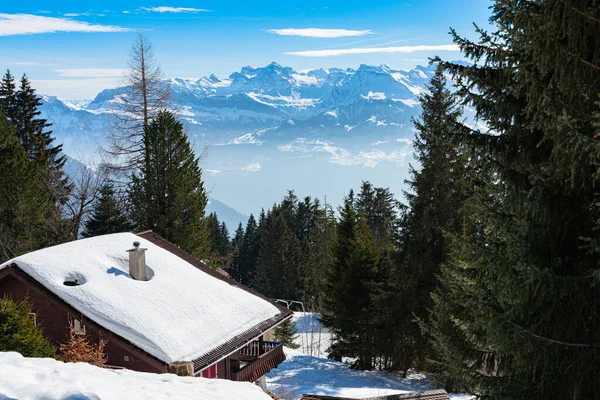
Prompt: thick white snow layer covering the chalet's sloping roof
<box><xmin>0</xmin><ymin>233</ymin><xmax>280</xmax><ymax>363</ymax></box>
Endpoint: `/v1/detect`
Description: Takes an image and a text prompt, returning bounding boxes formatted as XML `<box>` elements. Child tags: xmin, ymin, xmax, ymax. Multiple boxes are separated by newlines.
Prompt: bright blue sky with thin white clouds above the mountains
<box><xmin>0</xmin><ymin>0</ymin><xmax>491</xmax><ymax>99</ymax></box>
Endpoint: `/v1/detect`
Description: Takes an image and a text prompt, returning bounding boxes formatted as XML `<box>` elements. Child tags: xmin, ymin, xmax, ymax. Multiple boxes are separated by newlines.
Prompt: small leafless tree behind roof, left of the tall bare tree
<box><xmin>64</xmin><ymin>163</ymin><xmax>110</xmax><ymax>240</ymax></box>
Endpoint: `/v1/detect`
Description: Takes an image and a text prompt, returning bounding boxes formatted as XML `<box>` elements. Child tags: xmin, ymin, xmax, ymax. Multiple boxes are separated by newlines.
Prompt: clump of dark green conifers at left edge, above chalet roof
<box><xmin>0</xmin><ymin>71</ymin><xmax>71</xmax><ymax>256</ymax></box>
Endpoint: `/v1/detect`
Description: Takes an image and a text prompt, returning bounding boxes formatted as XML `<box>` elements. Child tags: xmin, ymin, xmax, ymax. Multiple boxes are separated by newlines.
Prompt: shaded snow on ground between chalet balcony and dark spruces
<box><xmin>266</xmin><ymin>312</ymin><xmax>472</xmax><ymax>400</ymax></box>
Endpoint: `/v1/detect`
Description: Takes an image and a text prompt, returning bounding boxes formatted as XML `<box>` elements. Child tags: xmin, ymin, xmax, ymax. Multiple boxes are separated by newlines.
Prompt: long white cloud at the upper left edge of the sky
<box><xmin>0</xmin><ymin>13</ymin><xmax>131</xmax><ymax>36</ymax></box>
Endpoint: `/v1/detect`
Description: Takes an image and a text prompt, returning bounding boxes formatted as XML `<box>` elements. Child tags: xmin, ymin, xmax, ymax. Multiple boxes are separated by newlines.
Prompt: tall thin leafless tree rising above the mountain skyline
<box><xmin>104</xmin><ymin>33</ymin><xmax>171</xmax><ymax>172</ymax></box>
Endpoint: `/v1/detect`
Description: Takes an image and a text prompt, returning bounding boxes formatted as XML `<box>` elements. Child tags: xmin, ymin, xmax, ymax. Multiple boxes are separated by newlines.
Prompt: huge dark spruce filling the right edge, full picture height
<box><xmin>431</xmin><ymin>0</ymin><xmax>600</xmax><ymax>400</ymax></box>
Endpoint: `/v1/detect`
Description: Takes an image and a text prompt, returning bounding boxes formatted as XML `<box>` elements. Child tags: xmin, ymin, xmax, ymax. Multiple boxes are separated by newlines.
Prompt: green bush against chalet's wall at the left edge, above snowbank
<box><xmin>0</xmin><ymin>297</ymin><xmax>56</xmax><ymax>357</ymax></box>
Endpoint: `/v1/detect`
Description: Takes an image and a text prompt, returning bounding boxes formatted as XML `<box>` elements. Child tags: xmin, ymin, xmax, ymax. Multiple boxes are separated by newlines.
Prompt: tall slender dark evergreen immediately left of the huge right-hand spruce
<box><xmin>378</xmin><ymin>70</ymin><xmax>473</xmax><ymax>371</ymax></box>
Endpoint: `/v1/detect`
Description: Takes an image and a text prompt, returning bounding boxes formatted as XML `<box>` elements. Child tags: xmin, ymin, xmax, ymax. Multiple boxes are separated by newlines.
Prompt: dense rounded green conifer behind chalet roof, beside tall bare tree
<box><xmin>129</xmin><ymin>111</ymin><xmax>210</xmax><ymax>259</ymax></box>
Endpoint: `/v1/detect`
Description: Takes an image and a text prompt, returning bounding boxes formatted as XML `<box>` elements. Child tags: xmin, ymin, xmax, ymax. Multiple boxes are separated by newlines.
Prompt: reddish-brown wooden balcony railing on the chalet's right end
<box><xmin>231</xmin><ymin>340</ymin><xmax>285</xmax><ymax>382</ymax></box>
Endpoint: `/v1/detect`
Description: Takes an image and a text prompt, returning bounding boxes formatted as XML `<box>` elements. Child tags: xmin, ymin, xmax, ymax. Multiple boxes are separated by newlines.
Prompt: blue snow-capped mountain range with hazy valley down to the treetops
<box><xmin>42</xmin><ymin>62</ymin><xmax>435</xmax><ymax>215</ymax></box>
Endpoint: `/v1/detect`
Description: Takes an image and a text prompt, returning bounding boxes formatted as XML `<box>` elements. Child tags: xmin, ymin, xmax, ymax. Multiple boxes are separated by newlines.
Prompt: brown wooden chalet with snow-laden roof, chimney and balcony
<box><xmin>0</xmin><ymin>231</ymin><xmax>291</xmax><ymax>382</ymax></box>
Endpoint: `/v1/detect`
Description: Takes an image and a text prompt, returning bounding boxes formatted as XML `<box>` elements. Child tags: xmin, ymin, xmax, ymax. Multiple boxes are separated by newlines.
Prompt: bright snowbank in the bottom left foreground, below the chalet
<box><xmin>0</xmin><ymin>352</ymin><xmax>270</xmax><ymax>400</ymax></box>
